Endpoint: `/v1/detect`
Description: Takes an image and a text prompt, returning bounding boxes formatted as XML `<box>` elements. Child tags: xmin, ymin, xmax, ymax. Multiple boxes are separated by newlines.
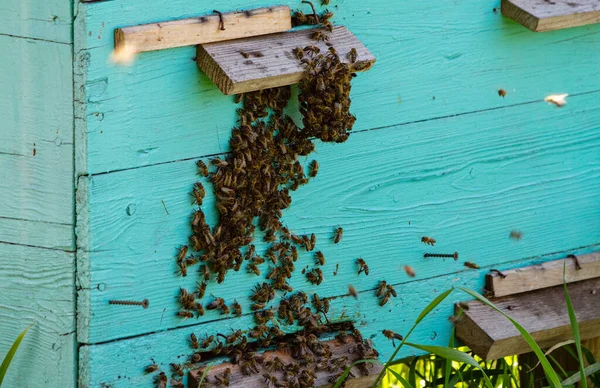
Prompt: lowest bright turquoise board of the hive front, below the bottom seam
<box><xmin>79</xmin><ymin>258</ymin><xmax>580</xmax><ymax>388</ymax></box>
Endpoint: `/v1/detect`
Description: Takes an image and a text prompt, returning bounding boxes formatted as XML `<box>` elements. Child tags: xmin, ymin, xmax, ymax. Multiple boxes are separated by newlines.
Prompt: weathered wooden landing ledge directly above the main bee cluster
<box><xmin>196</xmin><ymin>26</ymin><xmax>375</xmax><ymax>94</ymax></box>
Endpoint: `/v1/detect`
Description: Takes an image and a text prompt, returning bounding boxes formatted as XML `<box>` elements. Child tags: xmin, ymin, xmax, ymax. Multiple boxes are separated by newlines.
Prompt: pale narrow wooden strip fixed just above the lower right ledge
<box><xmin>486</xmin><ymin>252</ymin><xmax>600</xmax><ymax>297</ymax></box>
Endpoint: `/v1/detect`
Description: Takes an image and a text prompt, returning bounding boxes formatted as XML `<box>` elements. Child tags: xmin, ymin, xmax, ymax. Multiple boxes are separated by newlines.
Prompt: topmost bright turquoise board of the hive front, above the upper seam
<box><xmin>75</xmin><ymin>0</ymin><xmax>600</xmax><ymax>173</ymax></box>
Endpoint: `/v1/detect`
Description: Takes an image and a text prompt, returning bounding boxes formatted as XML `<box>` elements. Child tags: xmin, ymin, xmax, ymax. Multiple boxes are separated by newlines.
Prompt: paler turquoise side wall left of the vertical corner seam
<box><xmin>0</xmin><ymin>0</ymin><xmax>77</xmax><ymax>388</ymax></box>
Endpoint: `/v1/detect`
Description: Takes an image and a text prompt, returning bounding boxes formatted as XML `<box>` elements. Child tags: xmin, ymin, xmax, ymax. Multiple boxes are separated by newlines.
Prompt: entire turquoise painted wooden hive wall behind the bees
<box><xmin>0</xmin><ymin>0</ymin><xmax>600</xmax><ymax>387</ymax></box>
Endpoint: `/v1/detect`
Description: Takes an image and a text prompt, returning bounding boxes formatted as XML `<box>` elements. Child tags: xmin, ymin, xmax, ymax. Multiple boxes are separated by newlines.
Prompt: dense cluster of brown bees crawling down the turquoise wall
<box><xmin>146</xmin><ymin>4</ymin><xmax>386</xmax><ymax>387</ymax></box>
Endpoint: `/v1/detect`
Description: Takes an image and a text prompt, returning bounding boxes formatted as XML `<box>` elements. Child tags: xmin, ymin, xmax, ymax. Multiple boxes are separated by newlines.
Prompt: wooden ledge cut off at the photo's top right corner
<box><xmin>501</xmin><ymin>0</ymin><xmax>600</xmax><ymax>32</ymax></box>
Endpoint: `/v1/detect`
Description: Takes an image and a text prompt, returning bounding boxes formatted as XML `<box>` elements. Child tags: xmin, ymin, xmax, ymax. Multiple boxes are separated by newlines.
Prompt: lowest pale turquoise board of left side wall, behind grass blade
<box><xmin>0</xmin><ymin>243</ymin><xmax>77</xmax><ymax>388</ymax></box>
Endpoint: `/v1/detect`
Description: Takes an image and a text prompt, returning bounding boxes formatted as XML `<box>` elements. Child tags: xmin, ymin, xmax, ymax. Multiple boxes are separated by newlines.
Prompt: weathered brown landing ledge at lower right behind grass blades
<box><xmin>456</xmin><ymin>278</ymin><xmax>600</xmax><ymax>360</ymax></box>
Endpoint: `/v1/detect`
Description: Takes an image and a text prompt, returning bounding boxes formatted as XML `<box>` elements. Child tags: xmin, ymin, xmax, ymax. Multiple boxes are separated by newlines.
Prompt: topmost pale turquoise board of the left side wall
<box><xmin>0</xmin><ymin>0</ymin><xmax>73</xmax><ymax>44</ymax></box>
